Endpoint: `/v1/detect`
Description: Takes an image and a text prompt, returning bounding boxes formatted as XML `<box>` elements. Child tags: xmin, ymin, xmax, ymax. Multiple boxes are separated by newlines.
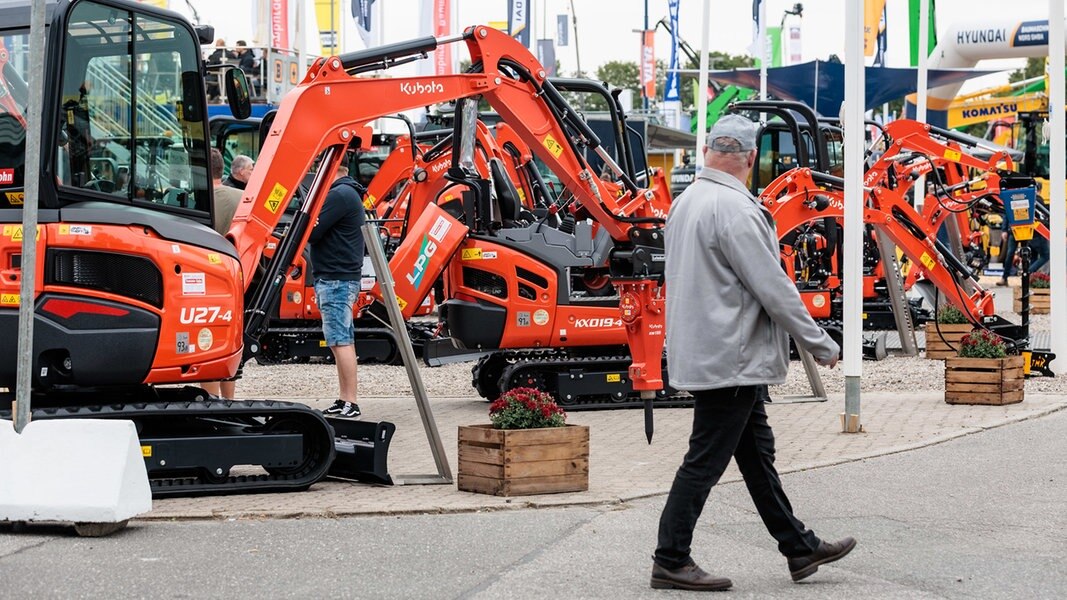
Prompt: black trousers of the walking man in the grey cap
<box><xmin>655</xmin><ymin>385</ymin><xmax>819</xmax><ymax>569</ymax></box>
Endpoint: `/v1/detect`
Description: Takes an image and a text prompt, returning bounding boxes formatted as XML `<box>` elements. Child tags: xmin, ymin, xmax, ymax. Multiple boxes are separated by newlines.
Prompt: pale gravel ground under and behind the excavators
<box><xmin>237</xmin><ymin>314</ymin><xmax>1067</xmax><ymax>399</ymax></box>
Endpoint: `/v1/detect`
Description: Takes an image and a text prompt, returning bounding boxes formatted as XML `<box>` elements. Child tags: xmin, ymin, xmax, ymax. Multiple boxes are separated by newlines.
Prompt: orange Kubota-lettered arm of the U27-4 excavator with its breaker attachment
<box><xmin>228</xmin><ymin>26</ymin><xmax>663</xmax><ymax>390</ymax></box>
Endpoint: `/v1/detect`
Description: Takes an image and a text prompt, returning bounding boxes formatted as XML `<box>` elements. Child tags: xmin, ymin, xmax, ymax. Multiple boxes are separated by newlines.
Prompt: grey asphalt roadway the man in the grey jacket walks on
<box><xmin>0</xmin><ymin>403</ymin><xmax>1067</xmax><ymax>600</ymax></box>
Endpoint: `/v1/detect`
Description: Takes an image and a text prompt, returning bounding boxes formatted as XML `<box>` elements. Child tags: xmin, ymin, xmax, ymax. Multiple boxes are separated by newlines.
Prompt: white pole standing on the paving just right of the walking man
<box><xmin>842</xmin><ymin>0</ymin><xmax>866</xmax><ymax>433</ymax></box>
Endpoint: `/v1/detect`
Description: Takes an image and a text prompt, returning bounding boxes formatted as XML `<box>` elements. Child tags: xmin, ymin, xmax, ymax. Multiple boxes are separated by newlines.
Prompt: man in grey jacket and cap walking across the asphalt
<box><xmin>651</xmin><ymin>115</ymin><xmax>856</xmax><ymax>590</ymax></box>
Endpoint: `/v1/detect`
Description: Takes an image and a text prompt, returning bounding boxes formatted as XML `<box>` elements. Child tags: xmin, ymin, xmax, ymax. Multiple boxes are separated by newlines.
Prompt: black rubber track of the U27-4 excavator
<box><xmin>0</xmin><ymin>400</ymin><xmax>334</xmax><ymax>498</ymax></box>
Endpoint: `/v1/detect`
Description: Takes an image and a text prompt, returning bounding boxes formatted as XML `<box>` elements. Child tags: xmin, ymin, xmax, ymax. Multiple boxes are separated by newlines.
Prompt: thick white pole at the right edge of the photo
<box><xmin>1049</xmin><ymin>0</ymin><xmax>1067</xmax><ymax>368</ymax></box>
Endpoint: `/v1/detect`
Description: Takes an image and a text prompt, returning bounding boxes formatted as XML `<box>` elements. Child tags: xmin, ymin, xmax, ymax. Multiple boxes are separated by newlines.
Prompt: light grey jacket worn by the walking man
<box><xmin>666</xmin><ymin>168</ymin><xmax>839</xmax><ymax>390</ymax></box>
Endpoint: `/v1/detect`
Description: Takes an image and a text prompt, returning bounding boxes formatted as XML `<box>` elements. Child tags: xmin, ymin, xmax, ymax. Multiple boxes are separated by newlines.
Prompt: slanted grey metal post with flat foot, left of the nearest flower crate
<box><xmin>363</xmin><ymin>223</ymin><xmax>452</xmax><ymax>485</ymax></box>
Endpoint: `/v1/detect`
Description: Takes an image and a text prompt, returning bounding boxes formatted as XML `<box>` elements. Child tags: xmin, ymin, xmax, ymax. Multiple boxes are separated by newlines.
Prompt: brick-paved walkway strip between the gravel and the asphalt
<box><xmin>146</xmin><ymin>391</ymin><xmax>1067</xmax><ymax>520</ymax></box>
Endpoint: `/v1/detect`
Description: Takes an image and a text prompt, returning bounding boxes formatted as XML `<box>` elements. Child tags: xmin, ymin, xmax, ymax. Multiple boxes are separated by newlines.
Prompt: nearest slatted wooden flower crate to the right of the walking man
<box><xmin>944</xmin><ymin>357</ymin><xmax>1024</xmax><ymax>405</ymax></box>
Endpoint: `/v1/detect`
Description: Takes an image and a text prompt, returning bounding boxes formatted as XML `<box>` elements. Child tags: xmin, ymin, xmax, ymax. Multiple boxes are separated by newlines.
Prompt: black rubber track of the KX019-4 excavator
<box><xmin>484</xmin><ymin>349</ymin><xmax>692</xmax><ymax>411</ymax></box>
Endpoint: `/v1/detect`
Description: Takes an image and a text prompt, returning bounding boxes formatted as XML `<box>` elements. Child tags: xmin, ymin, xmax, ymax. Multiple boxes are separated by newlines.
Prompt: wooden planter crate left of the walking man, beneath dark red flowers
<box><xmin>459</xmin><ymin>425</ymin><xmax>589</xmax><ymax>495</ymax></box>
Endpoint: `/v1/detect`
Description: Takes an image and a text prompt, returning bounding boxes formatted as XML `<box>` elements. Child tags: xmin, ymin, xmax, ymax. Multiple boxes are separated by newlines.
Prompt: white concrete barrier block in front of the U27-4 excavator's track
<box><xmin>0</xmin><ymin>419</ymin><xmax>152</xmax><ymax>523</ymax></box>
